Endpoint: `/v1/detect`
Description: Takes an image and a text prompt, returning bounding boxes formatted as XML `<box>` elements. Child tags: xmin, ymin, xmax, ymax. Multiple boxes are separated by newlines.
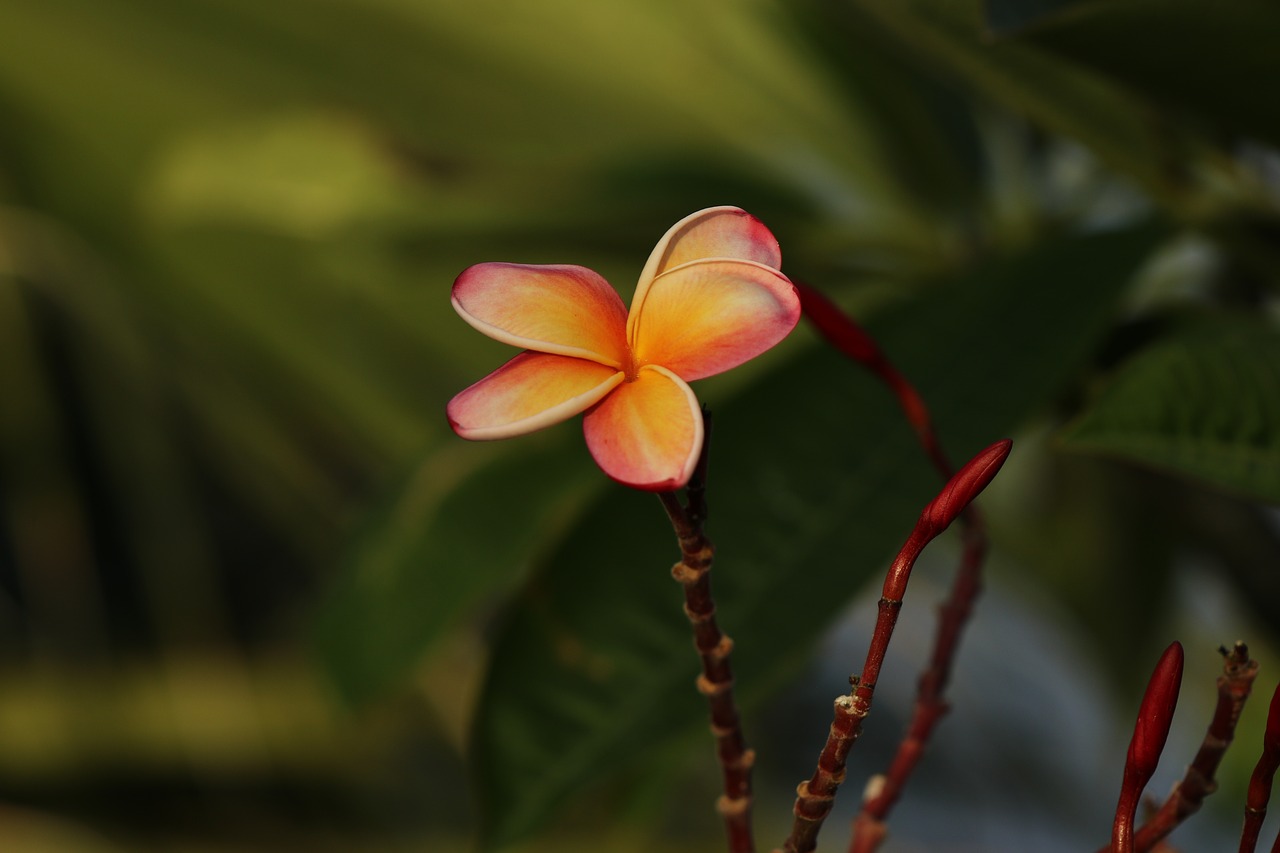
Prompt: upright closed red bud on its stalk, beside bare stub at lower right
<box><xmin>1110</xmin><ymin>642</ymin><xmax>1183</xmax><ymax>853</ymax></box>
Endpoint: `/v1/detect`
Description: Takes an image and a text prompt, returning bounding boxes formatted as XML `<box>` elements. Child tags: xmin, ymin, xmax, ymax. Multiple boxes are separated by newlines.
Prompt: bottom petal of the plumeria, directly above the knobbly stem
<box><xmin>582</xmin><ymin>365</ymin><xmax>703</xmax><ymax>492</ymax></box>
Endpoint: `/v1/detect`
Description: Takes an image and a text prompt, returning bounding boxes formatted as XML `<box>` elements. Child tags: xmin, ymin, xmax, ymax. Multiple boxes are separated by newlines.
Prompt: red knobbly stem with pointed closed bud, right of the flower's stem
<box><xmin>781</xmin><ymin>439</ymin><xmax>1012</xmax><ymax>853</ymax></box>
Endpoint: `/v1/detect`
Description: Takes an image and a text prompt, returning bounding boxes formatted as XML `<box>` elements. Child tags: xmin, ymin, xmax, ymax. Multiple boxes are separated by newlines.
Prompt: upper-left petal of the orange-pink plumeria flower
<box><xmin>453</xmin><ymin>258</ymin><xmax>628</xmax><ymax>368</ymax></box>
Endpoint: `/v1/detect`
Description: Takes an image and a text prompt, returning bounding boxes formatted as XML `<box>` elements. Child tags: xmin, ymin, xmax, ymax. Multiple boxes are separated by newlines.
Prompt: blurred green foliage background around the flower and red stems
<box><xmin>0</xmin><ymin>0</ymin><xmax>1280</xmax><ymax>853</ymax></box>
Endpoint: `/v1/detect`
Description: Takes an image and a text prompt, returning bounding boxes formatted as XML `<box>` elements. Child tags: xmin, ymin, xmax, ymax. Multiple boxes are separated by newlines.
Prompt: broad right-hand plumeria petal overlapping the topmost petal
<box><xmin>630</xmin><ymin>260</ymin><xmax>800</xmax><ymax>382</ymax></box>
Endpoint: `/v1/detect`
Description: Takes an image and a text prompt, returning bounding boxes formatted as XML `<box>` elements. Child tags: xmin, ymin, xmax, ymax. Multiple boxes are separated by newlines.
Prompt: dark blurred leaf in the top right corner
<box><xmin>1003</xmin><ymin>0</ymin><xmax>1280</xmax><ymax>145</ymax></box>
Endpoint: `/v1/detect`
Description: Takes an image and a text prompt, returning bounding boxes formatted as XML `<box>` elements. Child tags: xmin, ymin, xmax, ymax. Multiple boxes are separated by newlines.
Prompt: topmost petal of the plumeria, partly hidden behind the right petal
<box><xmin>627</xmin><ymin>207</ymin><xmax>782</xmax><ymax>339</ymax></box>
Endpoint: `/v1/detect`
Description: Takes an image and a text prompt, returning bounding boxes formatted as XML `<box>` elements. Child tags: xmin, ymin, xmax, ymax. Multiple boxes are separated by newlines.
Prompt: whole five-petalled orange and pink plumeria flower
<box><xmin>448</xmin><ymin>207</ymin><xmax>800</xmax><ymax>492</ymax></box>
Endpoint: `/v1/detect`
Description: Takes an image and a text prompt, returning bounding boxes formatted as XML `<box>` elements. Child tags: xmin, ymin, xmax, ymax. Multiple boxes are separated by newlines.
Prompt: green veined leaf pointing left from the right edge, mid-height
<box><xmin>1061</xmin><ymin>316</ymin><xmax>1280</xmax><ymax>503</ymax></box>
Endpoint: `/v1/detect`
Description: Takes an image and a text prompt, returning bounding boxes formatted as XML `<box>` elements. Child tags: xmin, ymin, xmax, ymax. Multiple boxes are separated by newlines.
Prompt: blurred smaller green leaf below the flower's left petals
<box><xmin>316</xmin><ymin>428</ymin><xmax>605</xmax><ymax>703</ymax></box>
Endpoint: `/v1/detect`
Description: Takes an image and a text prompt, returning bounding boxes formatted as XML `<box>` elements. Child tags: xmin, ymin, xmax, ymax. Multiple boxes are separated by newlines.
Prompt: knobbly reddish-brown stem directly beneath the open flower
<box><xmin>658</xmin><ymin>414</ymin><xmax>755</xmax><ymax>853</ymax></box>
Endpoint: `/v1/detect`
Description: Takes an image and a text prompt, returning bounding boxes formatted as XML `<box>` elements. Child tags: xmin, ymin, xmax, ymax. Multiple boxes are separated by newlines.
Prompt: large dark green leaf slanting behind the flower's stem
<box><xmin>472</xmin><ymin>222</ymin><xmax>1157</xmax><ymax>847</ymax></box>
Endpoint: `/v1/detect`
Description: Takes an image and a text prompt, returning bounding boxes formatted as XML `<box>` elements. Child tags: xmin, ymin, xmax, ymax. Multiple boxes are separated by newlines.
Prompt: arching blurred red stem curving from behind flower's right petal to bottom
<box><xmin>796</xmin><ymin>283</ymin><xmax>987</xmax><ymax>853</ymax></box>
